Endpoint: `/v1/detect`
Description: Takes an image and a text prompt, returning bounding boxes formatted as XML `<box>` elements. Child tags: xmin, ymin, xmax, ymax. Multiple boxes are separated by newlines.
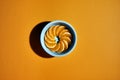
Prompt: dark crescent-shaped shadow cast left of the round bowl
<box><xmin>29</xmin><ymin>21</ymin><xmax>53</xmax><ymax>58</ymax></box>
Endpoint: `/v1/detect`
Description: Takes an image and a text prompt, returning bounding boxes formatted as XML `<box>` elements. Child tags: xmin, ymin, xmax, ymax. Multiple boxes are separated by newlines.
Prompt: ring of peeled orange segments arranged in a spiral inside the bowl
<box><xmin>45</xmin><ymin>25</ymin><xmax>72</xmax><ymax>53</ymax></box>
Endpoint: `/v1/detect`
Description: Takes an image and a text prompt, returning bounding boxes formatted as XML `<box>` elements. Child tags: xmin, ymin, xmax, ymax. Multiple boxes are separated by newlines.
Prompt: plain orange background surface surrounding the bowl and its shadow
<box><xmin>0</xmin><ymin>0</ymin><xmax>120</xmax><ymax>80</ymax></box>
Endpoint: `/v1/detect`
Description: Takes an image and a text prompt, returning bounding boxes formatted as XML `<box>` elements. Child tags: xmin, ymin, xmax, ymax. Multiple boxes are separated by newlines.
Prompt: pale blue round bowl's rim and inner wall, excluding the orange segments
<box><xmin>40</xmin><ymin>20</ymin><xmax>77</xmax><ymax>57</ymax></box>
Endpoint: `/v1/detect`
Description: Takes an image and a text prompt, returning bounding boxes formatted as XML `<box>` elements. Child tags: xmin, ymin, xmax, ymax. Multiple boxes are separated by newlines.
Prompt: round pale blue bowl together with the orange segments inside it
<box><xmin>40</xmin><ymin>20</ymin><xmax>77</xmax><ymax>57</ymax></box>
